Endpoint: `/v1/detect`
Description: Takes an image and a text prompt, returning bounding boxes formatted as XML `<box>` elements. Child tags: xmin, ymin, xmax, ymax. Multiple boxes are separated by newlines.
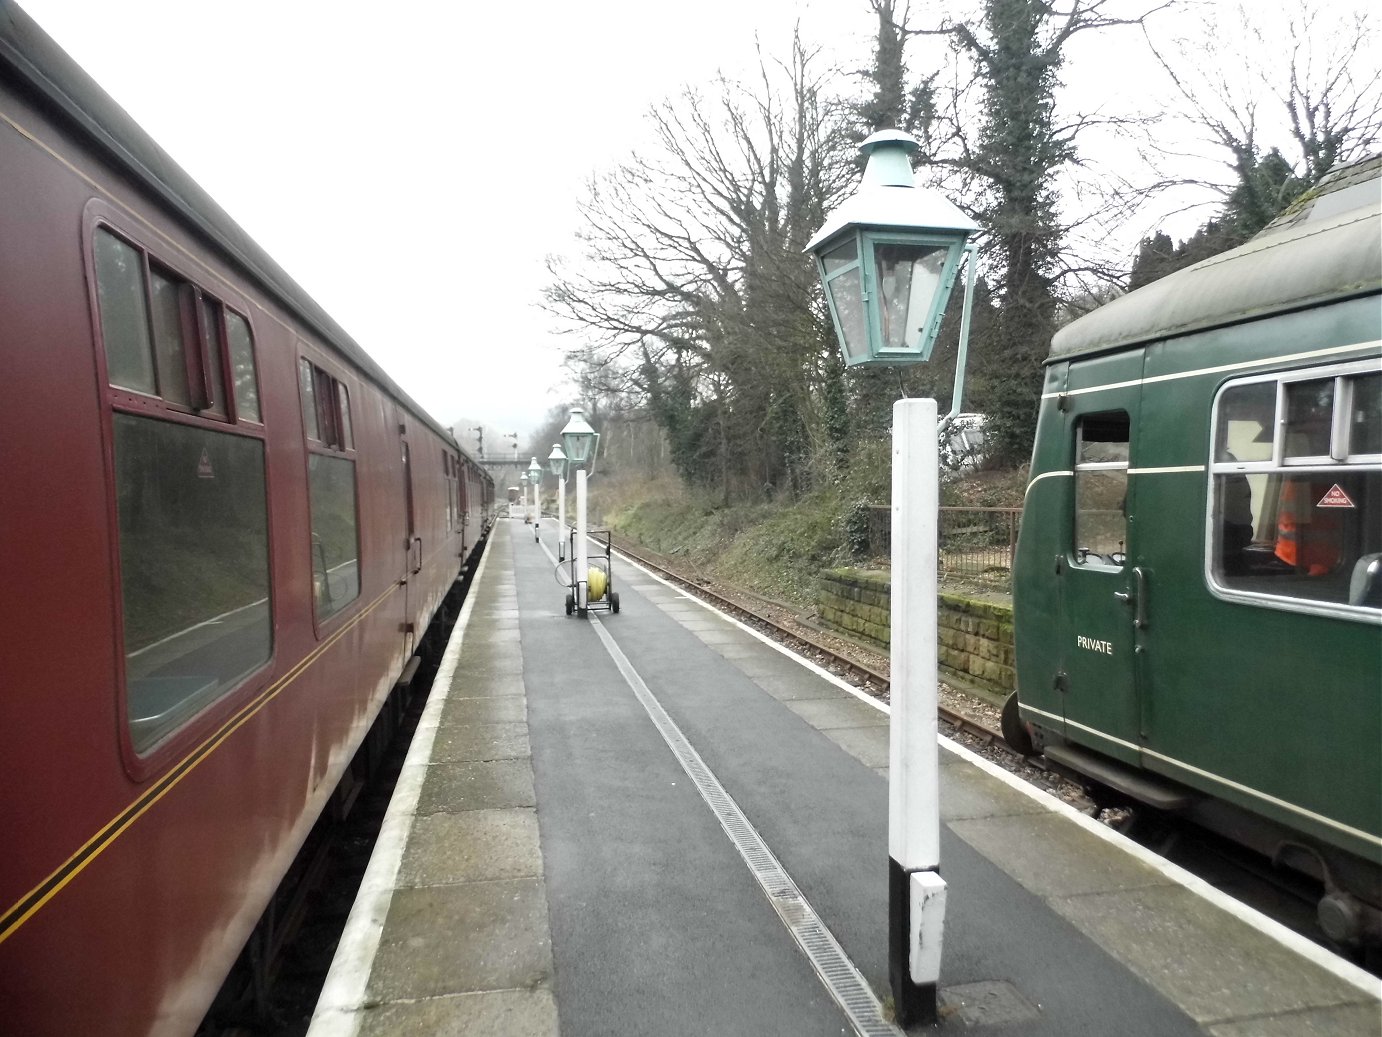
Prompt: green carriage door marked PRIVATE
<box><xmin>1056</xmin><ymin>350</ymin><xmax>1146</xmax><ymax>760</ymax></box>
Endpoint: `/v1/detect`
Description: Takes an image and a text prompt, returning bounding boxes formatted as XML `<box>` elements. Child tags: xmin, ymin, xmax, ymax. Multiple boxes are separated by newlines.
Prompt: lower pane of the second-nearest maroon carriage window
<box><xmin>307</xmin><ymin>454</ymin><xmax>359</xmax><ymax>621</ymax></box>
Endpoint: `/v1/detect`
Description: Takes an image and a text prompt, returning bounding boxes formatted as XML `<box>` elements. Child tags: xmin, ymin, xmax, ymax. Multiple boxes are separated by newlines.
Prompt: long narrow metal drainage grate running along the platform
<box><xmin>590</xmin><ymin>615</ymin><xmax>901</xmax><ymax>1037</ymax></box>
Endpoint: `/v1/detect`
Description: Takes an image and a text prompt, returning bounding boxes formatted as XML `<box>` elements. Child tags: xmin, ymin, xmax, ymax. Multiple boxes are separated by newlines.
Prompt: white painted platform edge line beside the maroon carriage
<box><xmin>307</xmin><ymin>541</ymin><xmax>495</xmax><ymax>1037</ymax></box>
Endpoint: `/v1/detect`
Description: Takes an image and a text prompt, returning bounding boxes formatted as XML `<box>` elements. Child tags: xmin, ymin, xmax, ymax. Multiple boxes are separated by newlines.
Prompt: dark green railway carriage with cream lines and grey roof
<box><xmin>1005</xmin><ymin>159</ymin><xmax>1382</xmax><ymax>944</ymax></box>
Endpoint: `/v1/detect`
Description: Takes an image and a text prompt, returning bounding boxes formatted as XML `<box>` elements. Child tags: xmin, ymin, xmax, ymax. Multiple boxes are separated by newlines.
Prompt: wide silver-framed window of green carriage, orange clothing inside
<box><xmin>1208</xmin><ymin>364</ymin><xmax>1382</xmax><ymax>610</ymax></box>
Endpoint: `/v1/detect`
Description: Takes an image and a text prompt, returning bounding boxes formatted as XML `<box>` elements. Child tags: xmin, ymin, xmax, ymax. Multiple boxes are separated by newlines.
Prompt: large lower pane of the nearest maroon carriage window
<box><xmin>113</xmin><ymin>413</ymin><xmax>274</xmax><ymax>752</ymax></box>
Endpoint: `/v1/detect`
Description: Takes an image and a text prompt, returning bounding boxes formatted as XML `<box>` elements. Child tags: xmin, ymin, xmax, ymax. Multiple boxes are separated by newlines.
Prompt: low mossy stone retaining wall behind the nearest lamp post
<box><xmin>817</xmin><ymin>568</ymin><xmax>1017</xmax><ymax>693</ymax></box>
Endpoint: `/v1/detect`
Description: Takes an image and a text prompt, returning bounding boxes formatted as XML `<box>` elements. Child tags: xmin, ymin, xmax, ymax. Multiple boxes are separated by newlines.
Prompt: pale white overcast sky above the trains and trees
<box><xmin>19</xmin><ymin>0</ymin><xmax>1376</xmax><ymax>447</ymax></box>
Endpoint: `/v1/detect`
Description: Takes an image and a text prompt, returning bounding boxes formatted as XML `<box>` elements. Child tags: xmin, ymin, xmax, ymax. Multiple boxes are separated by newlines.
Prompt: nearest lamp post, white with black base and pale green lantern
<box><xmin>806</xmin><ymin>130</ymin><xmax>978</xmax><ymax>1027</ymax></box>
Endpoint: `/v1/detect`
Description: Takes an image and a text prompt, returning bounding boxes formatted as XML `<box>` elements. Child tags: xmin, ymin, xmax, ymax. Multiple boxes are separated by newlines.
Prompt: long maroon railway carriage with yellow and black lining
<box><xmin>0</xmin><ymin>0</ymin><xmax>493</xmax><ymax>1037</ymax></box>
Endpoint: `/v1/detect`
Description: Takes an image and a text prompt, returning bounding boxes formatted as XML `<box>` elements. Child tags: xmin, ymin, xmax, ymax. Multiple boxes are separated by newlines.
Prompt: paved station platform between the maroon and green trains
<box><xmin>311</xmin><ymin>521</ymin><xmax>1382</xmax><ymax>1037</ymax></box>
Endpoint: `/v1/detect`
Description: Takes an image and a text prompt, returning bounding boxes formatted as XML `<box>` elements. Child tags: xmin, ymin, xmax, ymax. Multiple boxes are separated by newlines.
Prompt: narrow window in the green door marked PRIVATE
<box><xmin>1074</xmin><ymin>411</ymin><xmax>1130</xmax><ymax>566</ymax></box>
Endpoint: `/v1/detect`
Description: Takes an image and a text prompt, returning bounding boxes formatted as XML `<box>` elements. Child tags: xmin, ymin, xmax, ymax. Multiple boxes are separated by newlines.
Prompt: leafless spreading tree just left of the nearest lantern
<box><xmin>547</xmin><ymin>37</ymin><xmax>850</xmax><ymax>495</ymax></box>
